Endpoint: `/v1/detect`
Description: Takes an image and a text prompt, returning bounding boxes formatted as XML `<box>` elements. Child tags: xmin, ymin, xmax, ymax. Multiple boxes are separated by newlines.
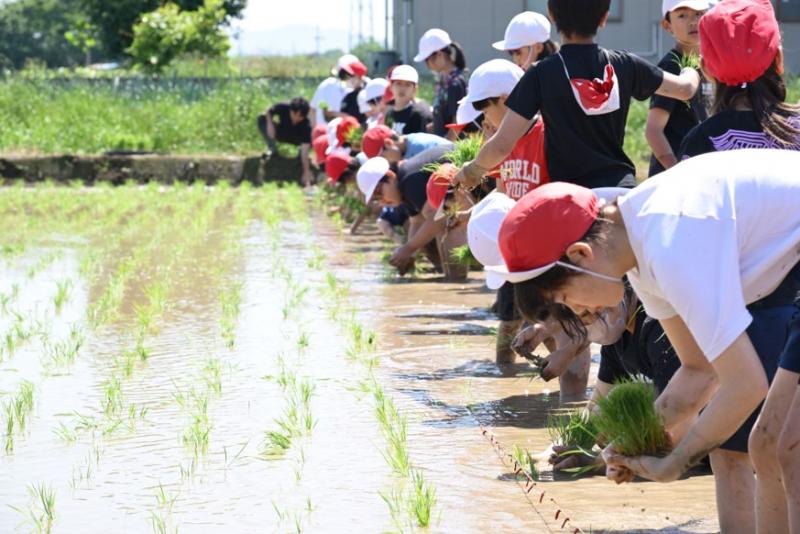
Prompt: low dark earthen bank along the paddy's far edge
<box><xmin>0</xmin><ymin>154</ymin><xmax>302</xmax><ymax>185</ymax></box>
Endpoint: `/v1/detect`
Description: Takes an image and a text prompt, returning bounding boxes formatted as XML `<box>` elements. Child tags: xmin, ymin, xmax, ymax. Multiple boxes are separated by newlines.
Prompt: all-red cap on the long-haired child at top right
<box><xmin>700</xmin><ymin>0</ymin><xmax>781</xmax><ymax>85</ymax></box>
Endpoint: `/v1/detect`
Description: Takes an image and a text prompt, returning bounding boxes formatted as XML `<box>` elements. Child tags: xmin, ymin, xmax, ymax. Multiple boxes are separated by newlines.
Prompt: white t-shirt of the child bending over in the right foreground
<box><xmin>619</xmin><ymin>149</ymin><xmax>800</xmax><ymax>360</ymax></box>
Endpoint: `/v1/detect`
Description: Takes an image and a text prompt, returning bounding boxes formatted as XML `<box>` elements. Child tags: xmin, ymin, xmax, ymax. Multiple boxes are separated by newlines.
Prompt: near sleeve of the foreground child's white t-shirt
<box><xmin>640</xmin><ymin>215</ymin><xmax>752</xmax><ymax>361</ymax></box>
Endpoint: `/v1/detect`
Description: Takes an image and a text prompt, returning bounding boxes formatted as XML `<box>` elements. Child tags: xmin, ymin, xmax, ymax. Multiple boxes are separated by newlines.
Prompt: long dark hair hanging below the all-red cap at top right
<box><xmin>713</xmin><ymin>65</ymin><xmax>800</xmax><ymax>147</ymax></box>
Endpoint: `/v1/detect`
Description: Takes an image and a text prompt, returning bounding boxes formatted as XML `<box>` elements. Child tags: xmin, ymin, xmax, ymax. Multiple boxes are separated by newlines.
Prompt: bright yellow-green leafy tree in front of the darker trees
<box><xmin>126</xmin><ymin>0</ymin><xmax>230</xmax><ymax>72</ymax></box>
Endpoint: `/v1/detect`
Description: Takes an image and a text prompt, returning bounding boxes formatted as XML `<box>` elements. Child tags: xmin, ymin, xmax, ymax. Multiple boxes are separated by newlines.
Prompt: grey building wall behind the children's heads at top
<box><xmin>393</xmin><ymin>0</ymin><xmax>800</xmax><ymax>72</ymax></box>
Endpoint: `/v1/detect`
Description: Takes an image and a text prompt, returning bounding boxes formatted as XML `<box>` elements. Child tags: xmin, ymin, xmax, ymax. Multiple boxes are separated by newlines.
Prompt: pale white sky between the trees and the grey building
<box><xmin>232</xmin><ymin>0</ymin><xmax>391</xmax><ymax>53</ymax></box>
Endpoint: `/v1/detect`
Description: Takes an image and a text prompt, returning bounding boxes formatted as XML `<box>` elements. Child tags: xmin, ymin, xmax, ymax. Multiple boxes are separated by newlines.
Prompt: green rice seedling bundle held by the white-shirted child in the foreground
<box><xmin>593</xmin><ymin>377</ymin><xmax>669</xmax><ymax>456</ymax></box>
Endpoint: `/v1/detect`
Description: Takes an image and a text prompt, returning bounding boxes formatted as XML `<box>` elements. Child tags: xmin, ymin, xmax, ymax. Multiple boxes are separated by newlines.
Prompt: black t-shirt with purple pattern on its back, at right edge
<box><xmin>678</xmin><ymin>109</ymin><xmax>800</xmax><ymax>159</ymax></box>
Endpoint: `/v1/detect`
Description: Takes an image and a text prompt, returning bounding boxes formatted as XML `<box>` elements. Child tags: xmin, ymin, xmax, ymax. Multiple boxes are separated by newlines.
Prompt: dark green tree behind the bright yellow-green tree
<box><xmin>79</xmin><ymin>0</ymin><xmax>247</xmax><ymax>57</ymax></box>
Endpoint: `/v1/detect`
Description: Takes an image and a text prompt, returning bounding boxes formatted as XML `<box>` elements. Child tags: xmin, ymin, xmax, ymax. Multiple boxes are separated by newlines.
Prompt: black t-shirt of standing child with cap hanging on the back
<box><xmin>506</xmin><ymin>44</ymin><xmax>664</xmax><ymax>188</ymax></box>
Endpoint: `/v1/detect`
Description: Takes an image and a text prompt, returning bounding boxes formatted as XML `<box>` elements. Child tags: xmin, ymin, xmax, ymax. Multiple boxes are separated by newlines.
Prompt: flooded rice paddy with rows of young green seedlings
<box><xmin>0</xmin><ymin>185</ymin><xmax>718</xmax><ymax>533</ymax></box>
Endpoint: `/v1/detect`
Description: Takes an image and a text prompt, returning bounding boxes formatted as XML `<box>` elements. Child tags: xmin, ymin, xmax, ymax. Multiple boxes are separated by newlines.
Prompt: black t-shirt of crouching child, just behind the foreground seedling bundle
<box><xmin>597</xmin><ymin>307</ymin><xmax>681</xmax><ymax>393</ymax></box>
